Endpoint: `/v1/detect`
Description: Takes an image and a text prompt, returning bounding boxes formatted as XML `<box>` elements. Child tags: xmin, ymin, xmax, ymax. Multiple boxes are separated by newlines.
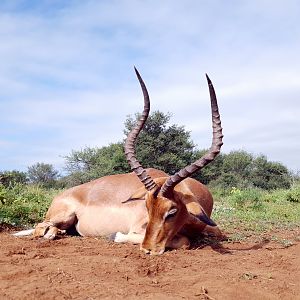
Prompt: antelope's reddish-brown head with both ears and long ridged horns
<box><xmin>124</xmin><ymin>69</ymin><xmax>223</xmax><ymax>255</ymax></box>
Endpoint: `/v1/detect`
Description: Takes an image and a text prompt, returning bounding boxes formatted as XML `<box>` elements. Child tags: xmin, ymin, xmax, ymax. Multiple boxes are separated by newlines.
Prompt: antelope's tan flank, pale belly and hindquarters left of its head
<box><xmin>35</xmin><ymin>169</ymin><xmax>167</xmax><ymax>239</ymax></box>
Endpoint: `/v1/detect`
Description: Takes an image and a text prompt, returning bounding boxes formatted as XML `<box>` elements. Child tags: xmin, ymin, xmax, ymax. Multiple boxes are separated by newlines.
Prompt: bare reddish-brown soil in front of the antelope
<box><xmin>0</xmin><ymin>228</ymin><xmax>300</xmax><ymax>300</ymax></box>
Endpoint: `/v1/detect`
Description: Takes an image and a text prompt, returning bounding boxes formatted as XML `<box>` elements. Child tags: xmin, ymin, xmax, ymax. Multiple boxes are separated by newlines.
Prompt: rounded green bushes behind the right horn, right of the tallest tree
<box><xmin>194</xmin><ymin>150</ymin><xmax>293</xmax><ymax>190</ymax></box>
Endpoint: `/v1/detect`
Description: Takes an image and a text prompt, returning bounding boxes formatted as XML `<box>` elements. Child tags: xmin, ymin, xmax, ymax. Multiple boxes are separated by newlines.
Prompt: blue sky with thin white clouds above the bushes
<box><xmin>0</xmin><ymin>0</ymin><xmax>300</xmax><ymax>172</ymax></box>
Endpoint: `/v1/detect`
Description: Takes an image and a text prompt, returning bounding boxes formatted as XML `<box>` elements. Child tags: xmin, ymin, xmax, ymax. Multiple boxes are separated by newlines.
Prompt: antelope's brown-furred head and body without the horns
<box><xmin>34</xmin><ymin>169</ymin><xmax>217</xmax><ymax>255</ymax></box>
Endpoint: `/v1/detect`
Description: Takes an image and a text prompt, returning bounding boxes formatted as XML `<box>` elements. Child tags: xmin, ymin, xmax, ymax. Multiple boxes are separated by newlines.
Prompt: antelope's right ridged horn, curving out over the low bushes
<box><xmin>161</xmin><ymin>74</ymin><xmax>223</xmax><ymax>197</ymax></box>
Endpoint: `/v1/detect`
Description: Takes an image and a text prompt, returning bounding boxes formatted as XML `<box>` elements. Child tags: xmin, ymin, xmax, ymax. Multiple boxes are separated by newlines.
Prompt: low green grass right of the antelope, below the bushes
<box><xmin>212</xmin><ymin>183</ymin><xmax>300</xmax><ymax>236</ymax></box>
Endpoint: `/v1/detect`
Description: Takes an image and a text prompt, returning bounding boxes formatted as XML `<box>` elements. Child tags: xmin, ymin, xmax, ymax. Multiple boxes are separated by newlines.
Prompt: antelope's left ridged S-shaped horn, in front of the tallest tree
<box><xmin>124</xmin><ymin>67</ymin><xmax>157</xmax><ymax>191</ymax></box>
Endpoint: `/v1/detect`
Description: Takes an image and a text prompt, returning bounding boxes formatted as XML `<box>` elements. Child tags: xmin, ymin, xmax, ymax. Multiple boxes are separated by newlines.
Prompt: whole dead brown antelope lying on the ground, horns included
<box><xmin>14</xmin><ymin>70</ymin><xmax>223</xmax><ymax>255</ymax></box>
